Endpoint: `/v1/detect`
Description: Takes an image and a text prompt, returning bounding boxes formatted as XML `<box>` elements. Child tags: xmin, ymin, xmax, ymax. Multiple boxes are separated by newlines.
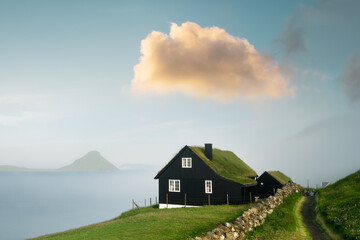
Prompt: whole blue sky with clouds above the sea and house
<box><xmin>0</xmin><ymin>0</ymin><xmax>360</xmax><ymax>186</ymax></box>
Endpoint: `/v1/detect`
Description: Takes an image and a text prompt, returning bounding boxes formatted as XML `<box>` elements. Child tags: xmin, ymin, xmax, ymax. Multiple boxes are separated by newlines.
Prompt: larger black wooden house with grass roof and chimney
<box><xmin>155</xmin><ymin>144</ymin><xmax>257</xmax><ymax>208</ymax></box>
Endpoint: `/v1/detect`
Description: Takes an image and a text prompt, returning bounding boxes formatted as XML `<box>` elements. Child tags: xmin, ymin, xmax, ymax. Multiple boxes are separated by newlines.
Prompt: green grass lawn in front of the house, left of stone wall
<box><xmin>30</xmin><ymin>205</ymin><xmax>249</xmax><ymax>240</ymax></box>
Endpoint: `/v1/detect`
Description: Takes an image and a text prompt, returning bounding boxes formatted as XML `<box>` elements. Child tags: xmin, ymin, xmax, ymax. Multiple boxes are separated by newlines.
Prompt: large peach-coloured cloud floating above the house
<box><xmin>132</xmin><ymin>22</ymin><xmax>292</xmax><ymax>101</ymax></box>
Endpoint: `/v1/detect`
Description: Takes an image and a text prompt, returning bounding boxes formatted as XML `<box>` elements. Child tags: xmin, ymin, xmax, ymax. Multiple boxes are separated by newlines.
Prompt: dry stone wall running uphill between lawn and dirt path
<box><xmin>190</xmin><ymin>183</ymin><xmax>301</xmax><ymax>240</ymax></box>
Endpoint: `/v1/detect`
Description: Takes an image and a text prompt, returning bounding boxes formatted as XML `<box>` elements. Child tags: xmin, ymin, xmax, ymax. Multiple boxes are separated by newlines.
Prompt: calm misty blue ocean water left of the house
<box><xmin>0</xmin><ymin>171</ymin><xmax>157</xmax><ymax>240</ymax></box>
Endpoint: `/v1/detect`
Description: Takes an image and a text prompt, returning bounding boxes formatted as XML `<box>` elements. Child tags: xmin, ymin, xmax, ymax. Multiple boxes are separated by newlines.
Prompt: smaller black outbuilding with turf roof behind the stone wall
<box><xmin>256</xmin><ymin>171</ymin><xmax>292</xmax><ymax>198</ymax></box>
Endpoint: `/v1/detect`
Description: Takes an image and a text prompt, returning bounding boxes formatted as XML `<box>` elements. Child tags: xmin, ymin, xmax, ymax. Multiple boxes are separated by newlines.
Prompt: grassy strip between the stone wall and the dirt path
<box><xmin>246</xmin><ymin>193</ymin><xmax>311</xmax><ymax>240</ymax></box>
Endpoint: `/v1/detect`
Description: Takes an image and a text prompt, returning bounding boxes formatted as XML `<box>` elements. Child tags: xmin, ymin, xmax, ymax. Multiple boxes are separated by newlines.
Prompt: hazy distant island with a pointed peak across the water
<box><xmin>0</xmin><ymin>151</ymin><xmax>119</xmax><ymax>172</ymax></box>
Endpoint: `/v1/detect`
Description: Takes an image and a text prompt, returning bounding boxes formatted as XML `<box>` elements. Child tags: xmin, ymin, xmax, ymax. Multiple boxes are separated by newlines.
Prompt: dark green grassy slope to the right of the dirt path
<box><xmin>317</xmin><ymin>170</ymin><xmax>360</xmax><ymax>239</ymax></box>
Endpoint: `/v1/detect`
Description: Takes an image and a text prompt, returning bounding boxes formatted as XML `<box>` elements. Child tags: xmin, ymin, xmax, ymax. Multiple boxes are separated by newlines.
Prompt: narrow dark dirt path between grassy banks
<box><xmin>301</xmin><ymin>197</ymin><xmax>330</xmax><ymax>240</ymax></box>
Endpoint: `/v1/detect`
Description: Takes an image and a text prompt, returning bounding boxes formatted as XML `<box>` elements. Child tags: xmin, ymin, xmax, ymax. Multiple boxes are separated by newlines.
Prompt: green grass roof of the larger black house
<box><xmin>190</xmin><ymin>146</ymin><xmax>257</xmax><ymax>184</ymax></box>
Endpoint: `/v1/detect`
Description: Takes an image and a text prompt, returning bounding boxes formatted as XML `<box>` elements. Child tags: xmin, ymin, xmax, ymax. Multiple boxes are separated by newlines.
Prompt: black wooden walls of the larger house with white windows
<box><xmin>159</xmin><ymin>146</ymin><xmax>257</xmax><ymax>206</ymax></box>
